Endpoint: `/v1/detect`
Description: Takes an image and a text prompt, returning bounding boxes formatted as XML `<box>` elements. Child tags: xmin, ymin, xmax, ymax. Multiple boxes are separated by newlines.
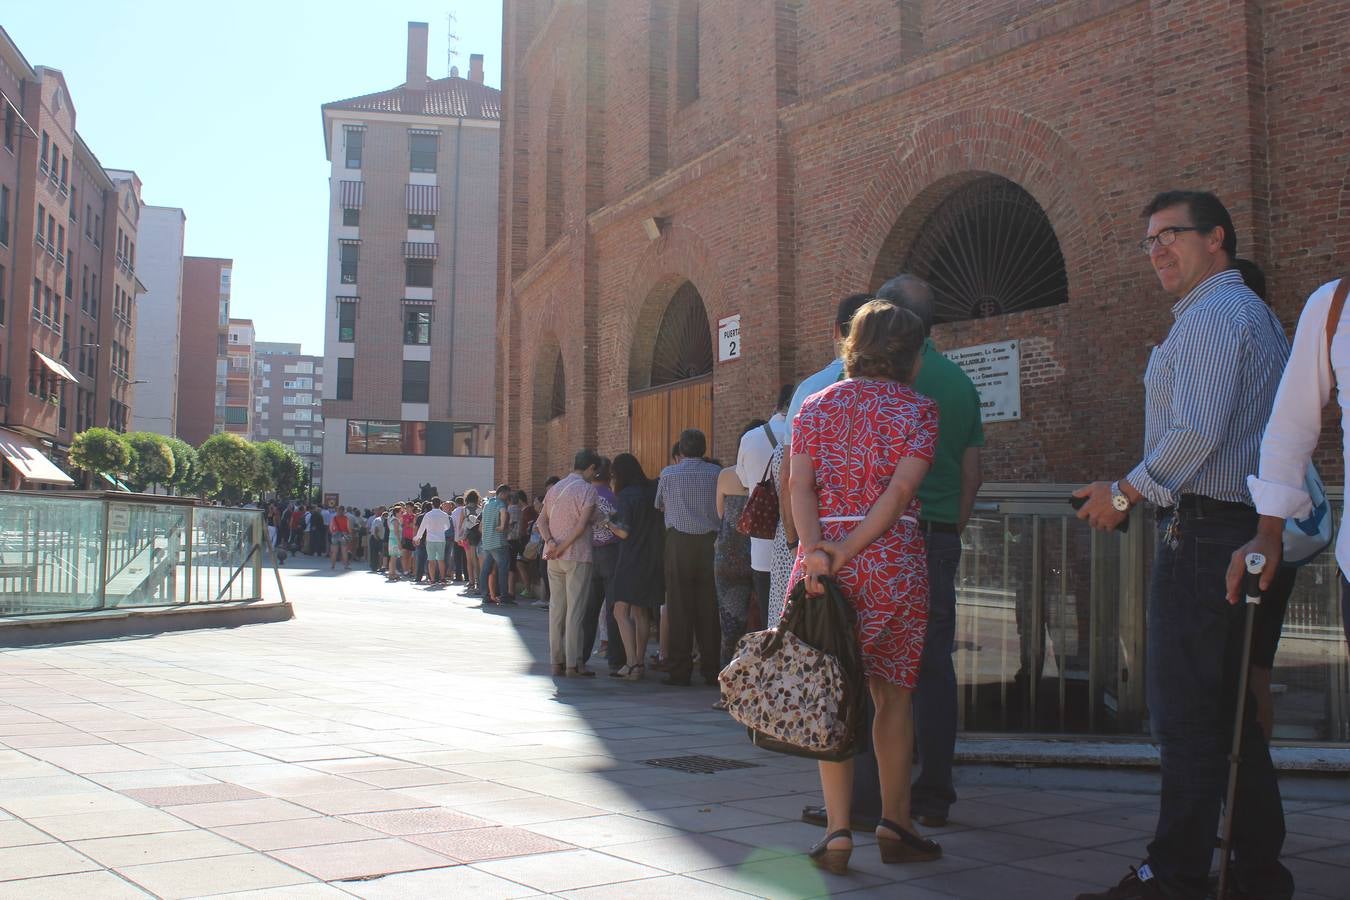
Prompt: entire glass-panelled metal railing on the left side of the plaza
<box><xmin>0</xmin><ymin>491</ymin><xmax>266</xmax><ymax>615</ymax></box>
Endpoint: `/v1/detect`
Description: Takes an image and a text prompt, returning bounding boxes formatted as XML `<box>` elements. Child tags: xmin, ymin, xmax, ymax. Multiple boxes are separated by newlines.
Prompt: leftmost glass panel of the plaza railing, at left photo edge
<box><xmin>0</xmin><ymin>494</ymin><xmax>104</xmax><ymax>615</ymax></box>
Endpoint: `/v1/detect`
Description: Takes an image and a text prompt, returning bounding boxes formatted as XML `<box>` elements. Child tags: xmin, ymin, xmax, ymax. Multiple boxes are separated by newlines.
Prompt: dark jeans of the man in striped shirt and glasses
<box><xmin>1146</xmin><ymin>510</ymin><xmax>1293</xmax><ymax>899</ymax></box>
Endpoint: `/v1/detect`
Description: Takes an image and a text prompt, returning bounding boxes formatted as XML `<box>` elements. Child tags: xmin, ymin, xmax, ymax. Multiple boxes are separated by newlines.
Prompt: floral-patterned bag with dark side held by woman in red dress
<box><xmin>718</xmin><ymin>579</ymin><xmax>864</xmax><ymax>762</ymax></box>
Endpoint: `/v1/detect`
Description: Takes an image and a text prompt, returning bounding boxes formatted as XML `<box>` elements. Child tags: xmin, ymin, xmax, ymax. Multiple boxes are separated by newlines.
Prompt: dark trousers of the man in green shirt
<box><xmin>911</xmin><ymin>532</ymin><xmax>961</xmax><ymax>815</ymax></box>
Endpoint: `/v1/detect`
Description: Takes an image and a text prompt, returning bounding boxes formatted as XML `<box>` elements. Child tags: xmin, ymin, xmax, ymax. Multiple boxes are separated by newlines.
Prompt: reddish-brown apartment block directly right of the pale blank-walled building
<box><xmin>178</xmin><ymin>256</ymin><xmax>234</xmax><ymax>447</ymax></box>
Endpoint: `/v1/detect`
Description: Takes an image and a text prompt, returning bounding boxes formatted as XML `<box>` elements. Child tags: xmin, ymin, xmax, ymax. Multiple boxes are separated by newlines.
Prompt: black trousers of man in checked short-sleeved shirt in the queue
<box><xmin>666</xmin><ymin>528</ymin><xmax>722</xmax><ymax>680</ymax></box>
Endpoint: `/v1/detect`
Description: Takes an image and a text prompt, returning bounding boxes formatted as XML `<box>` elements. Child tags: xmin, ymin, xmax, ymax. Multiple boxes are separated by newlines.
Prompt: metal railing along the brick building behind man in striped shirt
<box><xmin>954</xmin><ymin>484</ymin><xmax>1350</xmax><ymax>743</ymax></box>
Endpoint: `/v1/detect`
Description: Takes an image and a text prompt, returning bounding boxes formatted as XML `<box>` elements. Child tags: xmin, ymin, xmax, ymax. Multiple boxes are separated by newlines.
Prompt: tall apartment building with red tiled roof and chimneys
<box><xmin>323</xmin><ymin>23</ymin><xmax>501</xmax><ymax>506</ymax></box>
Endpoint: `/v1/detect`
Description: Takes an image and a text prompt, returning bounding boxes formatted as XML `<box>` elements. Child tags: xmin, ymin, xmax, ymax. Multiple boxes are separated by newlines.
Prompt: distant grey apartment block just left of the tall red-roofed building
<box><xmin>254</xmin><ymin>341</ymin><xmax>324</xmax><ymax>487</ymax></box>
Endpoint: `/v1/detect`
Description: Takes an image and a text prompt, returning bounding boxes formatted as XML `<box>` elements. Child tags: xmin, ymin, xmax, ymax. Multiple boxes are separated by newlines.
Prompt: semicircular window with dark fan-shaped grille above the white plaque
<box><xmin>905</xmin><ymin>175</ymin><xmax>1069</xmax><ymax>322</ymax></box>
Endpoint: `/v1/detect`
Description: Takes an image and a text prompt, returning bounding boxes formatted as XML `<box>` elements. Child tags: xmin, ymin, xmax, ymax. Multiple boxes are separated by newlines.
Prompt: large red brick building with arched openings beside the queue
<box><xmin>497</xmin><ymin>0</ymin><xmax>1350</xmax><ymax>487</ymax></box>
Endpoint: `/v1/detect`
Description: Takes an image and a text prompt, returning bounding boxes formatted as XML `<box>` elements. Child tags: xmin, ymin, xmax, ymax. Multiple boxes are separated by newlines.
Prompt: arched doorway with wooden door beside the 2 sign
<box><xmin>628</xmin><ymin>279</ymin><xmax>713</xmax><ymax>478</ymax></box>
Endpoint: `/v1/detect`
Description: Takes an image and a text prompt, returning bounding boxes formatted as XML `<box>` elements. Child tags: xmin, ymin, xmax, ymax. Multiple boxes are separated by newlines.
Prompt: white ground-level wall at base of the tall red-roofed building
<box><xmin>323</xmin><ymin>418</ymin><xmax>497</xmax><ymax>509</ymax></box>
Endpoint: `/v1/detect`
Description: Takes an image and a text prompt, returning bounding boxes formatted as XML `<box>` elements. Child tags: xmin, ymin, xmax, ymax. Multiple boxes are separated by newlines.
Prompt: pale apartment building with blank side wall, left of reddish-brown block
<box><xmin>131</xmin><ymin>206</ymin><xmax>188</xmax><ymax>434</ymax></box>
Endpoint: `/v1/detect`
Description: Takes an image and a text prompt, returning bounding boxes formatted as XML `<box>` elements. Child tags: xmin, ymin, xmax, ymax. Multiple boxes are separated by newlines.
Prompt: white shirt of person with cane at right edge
<box><xmin>1247</xmin><ymin>281</ymin><xmax>1350</xmax><ymax>578</ymax></box>
